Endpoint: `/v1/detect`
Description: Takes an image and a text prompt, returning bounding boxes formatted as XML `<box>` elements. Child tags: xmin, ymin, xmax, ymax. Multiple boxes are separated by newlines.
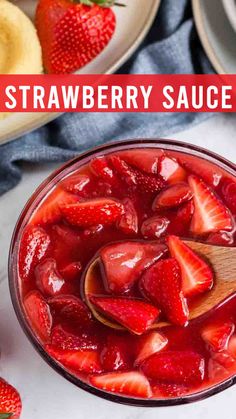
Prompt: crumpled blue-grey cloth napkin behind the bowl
<box><xmin>0</xmin><ymin>0</ymin><xmax>212</xmax><ymax>195</ymax></box>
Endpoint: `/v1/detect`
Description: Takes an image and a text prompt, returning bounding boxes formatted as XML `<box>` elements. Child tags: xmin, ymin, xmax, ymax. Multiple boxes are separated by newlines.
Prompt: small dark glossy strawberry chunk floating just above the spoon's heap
<box><xmin>141</xmin><ymin>215</ymin><xmax>170</xmax><ymax>239</ymax></box>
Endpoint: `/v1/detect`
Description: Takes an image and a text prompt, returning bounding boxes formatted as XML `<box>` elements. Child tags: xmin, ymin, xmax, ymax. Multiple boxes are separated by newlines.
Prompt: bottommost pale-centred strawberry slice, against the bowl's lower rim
<box><xmin>90</xmin><ymin>371</ymin><xmax>152</xmax><ymax>399</ymax></box>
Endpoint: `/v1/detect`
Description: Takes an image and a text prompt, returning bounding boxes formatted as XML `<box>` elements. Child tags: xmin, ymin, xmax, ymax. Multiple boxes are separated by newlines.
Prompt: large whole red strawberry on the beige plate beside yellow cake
<box><xmin>35</xmin><ymin>0</ymin><xmax>116</xmax><ymax>74</ymax></box>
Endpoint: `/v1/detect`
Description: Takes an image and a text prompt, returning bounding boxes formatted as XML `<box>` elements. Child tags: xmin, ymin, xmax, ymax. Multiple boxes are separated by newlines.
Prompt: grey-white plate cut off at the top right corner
<box><xmin>192</xmin><ymin>0</ymin><xmax>236</xmax><ymax>74</ymax></box>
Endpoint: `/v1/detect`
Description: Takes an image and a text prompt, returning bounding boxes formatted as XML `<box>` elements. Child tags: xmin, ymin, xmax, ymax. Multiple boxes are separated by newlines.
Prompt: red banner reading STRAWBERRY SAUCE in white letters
<box><xmin>0</xmin><ymin>74</ymin><xmax>236</xmax><ymax>113</ymax></box>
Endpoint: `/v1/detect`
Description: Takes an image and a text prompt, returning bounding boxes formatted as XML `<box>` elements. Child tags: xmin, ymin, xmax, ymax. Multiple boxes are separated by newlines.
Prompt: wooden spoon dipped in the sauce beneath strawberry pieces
<box><xmin>84</xmin><ymin>241</ymin><xmax>236</xmax><ymax>330</ymax></box>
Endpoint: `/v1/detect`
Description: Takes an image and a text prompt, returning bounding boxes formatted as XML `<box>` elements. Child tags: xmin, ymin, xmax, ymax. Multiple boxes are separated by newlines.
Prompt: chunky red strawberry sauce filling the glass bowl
<box><xmin>15</xmin><ymin>148</ymin><xmax>236</xmax><ymax>399</ymax></box>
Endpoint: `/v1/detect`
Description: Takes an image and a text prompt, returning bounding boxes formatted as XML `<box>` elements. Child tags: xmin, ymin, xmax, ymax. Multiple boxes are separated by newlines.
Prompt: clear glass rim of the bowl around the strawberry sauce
<box><xmin>8</xmin><ymin>138</ymin><xmax>236</xmax><ymax>407</ymax></box>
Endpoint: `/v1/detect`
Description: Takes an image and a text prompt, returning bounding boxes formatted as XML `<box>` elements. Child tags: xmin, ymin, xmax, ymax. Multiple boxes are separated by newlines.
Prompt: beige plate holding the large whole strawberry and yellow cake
<box><xmin>0</xmin><ymin>0</ymin><xmax>161</xmax><ymax>143</ymax></box>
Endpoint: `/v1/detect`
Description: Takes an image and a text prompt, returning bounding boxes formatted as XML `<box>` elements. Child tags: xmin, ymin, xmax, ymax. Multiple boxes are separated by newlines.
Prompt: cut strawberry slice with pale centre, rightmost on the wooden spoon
<box><xmin>168</xmin><ymin>236</ymin><xmax>214</xmax><ymax>297</ymax></box>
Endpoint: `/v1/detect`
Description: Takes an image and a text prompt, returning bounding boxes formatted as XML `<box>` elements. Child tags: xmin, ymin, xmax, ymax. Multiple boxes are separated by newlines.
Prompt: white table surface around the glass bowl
<box><xmin>0</xmin><ymin>114</ymin><xmax>236</xmax><ymax>419</ymax></box>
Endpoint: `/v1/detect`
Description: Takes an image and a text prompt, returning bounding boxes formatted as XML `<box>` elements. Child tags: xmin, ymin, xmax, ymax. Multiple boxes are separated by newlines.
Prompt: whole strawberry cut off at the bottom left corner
<box><xmin>0</xmin><ymin>378</ymin><xmax>22</xmax><ymax>419</ymax></box>
